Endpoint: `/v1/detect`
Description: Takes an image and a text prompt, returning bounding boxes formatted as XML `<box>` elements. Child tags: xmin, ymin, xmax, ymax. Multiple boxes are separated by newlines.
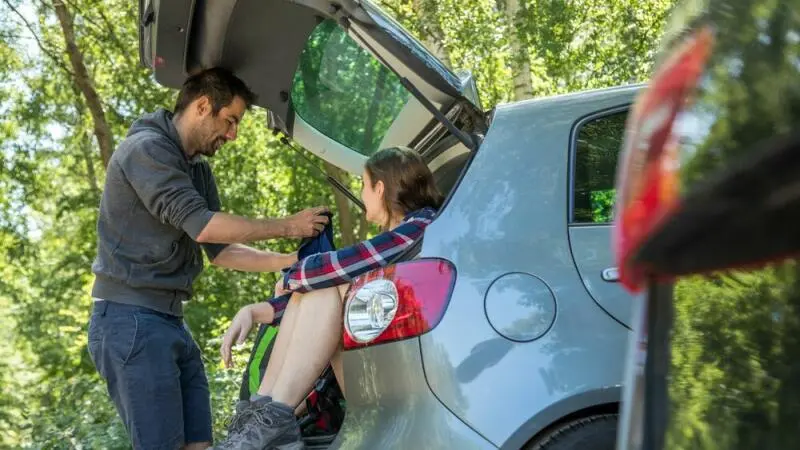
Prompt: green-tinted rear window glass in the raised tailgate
<box><xmin>291</xmin><ymin>19</ymin><xmax>410</xmax><ymax>156</ymax></box>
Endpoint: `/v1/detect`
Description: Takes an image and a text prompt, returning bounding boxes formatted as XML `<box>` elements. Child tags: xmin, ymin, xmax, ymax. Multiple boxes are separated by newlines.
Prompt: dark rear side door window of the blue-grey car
<box><xmin>572</xmin><ymin>111</ymin><xmax>628</xmax><ymax>224</ymax></box>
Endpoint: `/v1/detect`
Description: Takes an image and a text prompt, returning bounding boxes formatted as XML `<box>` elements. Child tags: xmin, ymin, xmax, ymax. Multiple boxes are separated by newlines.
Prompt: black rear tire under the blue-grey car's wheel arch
<box><xmin>523</xmin><ymin>414</ymin><xmax>617</xmax><ymax>450</ymax></box>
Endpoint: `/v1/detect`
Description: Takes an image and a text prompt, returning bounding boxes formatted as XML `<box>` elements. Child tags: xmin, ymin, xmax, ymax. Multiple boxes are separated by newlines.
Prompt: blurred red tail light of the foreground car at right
<box><xmin>613</xmin><ymin>27</ymin><xmax>713</xmax><ymax>291</ymax></box>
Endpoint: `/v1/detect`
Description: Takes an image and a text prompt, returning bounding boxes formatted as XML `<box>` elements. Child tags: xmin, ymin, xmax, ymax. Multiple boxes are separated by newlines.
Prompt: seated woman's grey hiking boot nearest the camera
<box><xmin>214</xmin><ymin>399</ymin><xmax>305</xmax><ymax>450</ymax></box>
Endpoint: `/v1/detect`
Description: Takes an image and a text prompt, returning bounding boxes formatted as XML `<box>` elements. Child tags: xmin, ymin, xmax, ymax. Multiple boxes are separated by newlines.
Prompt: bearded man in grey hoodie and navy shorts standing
<box><xmin>88</xmin><ymin>69</ymin><xmax>328</xmax><ymax>449</ymax></box>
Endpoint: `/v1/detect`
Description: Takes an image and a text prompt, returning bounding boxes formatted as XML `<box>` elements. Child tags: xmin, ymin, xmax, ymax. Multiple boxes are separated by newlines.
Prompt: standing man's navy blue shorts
<box><xmin>89</xmin><ymin>301</ymin><xmax>212</xmax><ymax>450</ymax></box>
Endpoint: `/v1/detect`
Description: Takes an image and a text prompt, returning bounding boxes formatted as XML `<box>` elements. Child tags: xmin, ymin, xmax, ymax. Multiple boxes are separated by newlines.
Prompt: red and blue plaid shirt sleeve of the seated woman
<box><xmin>283</xmin><ymin>208</ymin><xmax>436</xmax><ymax>292</ymax></box>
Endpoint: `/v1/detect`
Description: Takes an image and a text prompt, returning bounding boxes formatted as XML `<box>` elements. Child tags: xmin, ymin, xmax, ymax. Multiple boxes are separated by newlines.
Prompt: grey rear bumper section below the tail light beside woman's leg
<box><xmin>330</xmin><ymin>339</ymin><xmax>497</xmax><ymax>450</ymax></box>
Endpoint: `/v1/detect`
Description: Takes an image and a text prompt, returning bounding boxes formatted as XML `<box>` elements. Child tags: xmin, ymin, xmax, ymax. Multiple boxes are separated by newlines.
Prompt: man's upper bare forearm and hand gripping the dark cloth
<box><xmin>195</xmin><ymin>207</ymin><xmax>328</xmax><ymax>244</ymax></box>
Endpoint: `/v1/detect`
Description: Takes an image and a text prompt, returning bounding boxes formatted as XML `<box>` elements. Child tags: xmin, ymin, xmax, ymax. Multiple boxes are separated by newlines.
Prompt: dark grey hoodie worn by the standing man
<box><xmin>92</xmin><ymin>110</ymin><xmax>225</xmax><ymax>316</ymax></box>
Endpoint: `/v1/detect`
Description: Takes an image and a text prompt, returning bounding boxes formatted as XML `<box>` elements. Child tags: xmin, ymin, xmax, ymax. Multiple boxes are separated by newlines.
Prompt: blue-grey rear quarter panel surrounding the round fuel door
<box><xmin>406</xmin><ymin>87</ymin><xmax>636</xmax><ymax>448</ymax></box>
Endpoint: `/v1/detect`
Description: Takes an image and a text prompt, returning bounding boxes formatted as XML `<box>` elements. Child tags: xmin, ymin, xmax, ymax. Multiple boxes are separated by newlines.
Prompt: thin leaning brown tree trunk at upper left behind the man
<box><xmin>53</xmin><ymin>0</ymin><xmax>114</xmax><ymax>167</ymax></box>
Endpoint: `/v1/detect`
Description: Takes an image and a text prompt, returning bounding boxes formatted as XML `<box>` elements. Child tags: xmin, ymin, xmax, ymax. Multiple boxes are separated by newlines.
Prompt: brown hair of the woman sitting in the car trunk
<box><xmin>364</xmin><ymin>147</ymin><xmax>444</xmax><ymax>228</ymax></box>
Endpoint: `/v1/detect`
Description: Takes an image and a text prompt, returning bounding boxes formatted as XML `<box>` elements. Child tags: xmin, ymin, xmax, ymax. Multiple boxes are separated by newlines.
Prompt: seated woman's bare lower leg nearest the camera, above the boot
<box><xmin>272</xmin><ymin>287</ymin><xmax>342</xmax><ymax>408</ymax></box>
